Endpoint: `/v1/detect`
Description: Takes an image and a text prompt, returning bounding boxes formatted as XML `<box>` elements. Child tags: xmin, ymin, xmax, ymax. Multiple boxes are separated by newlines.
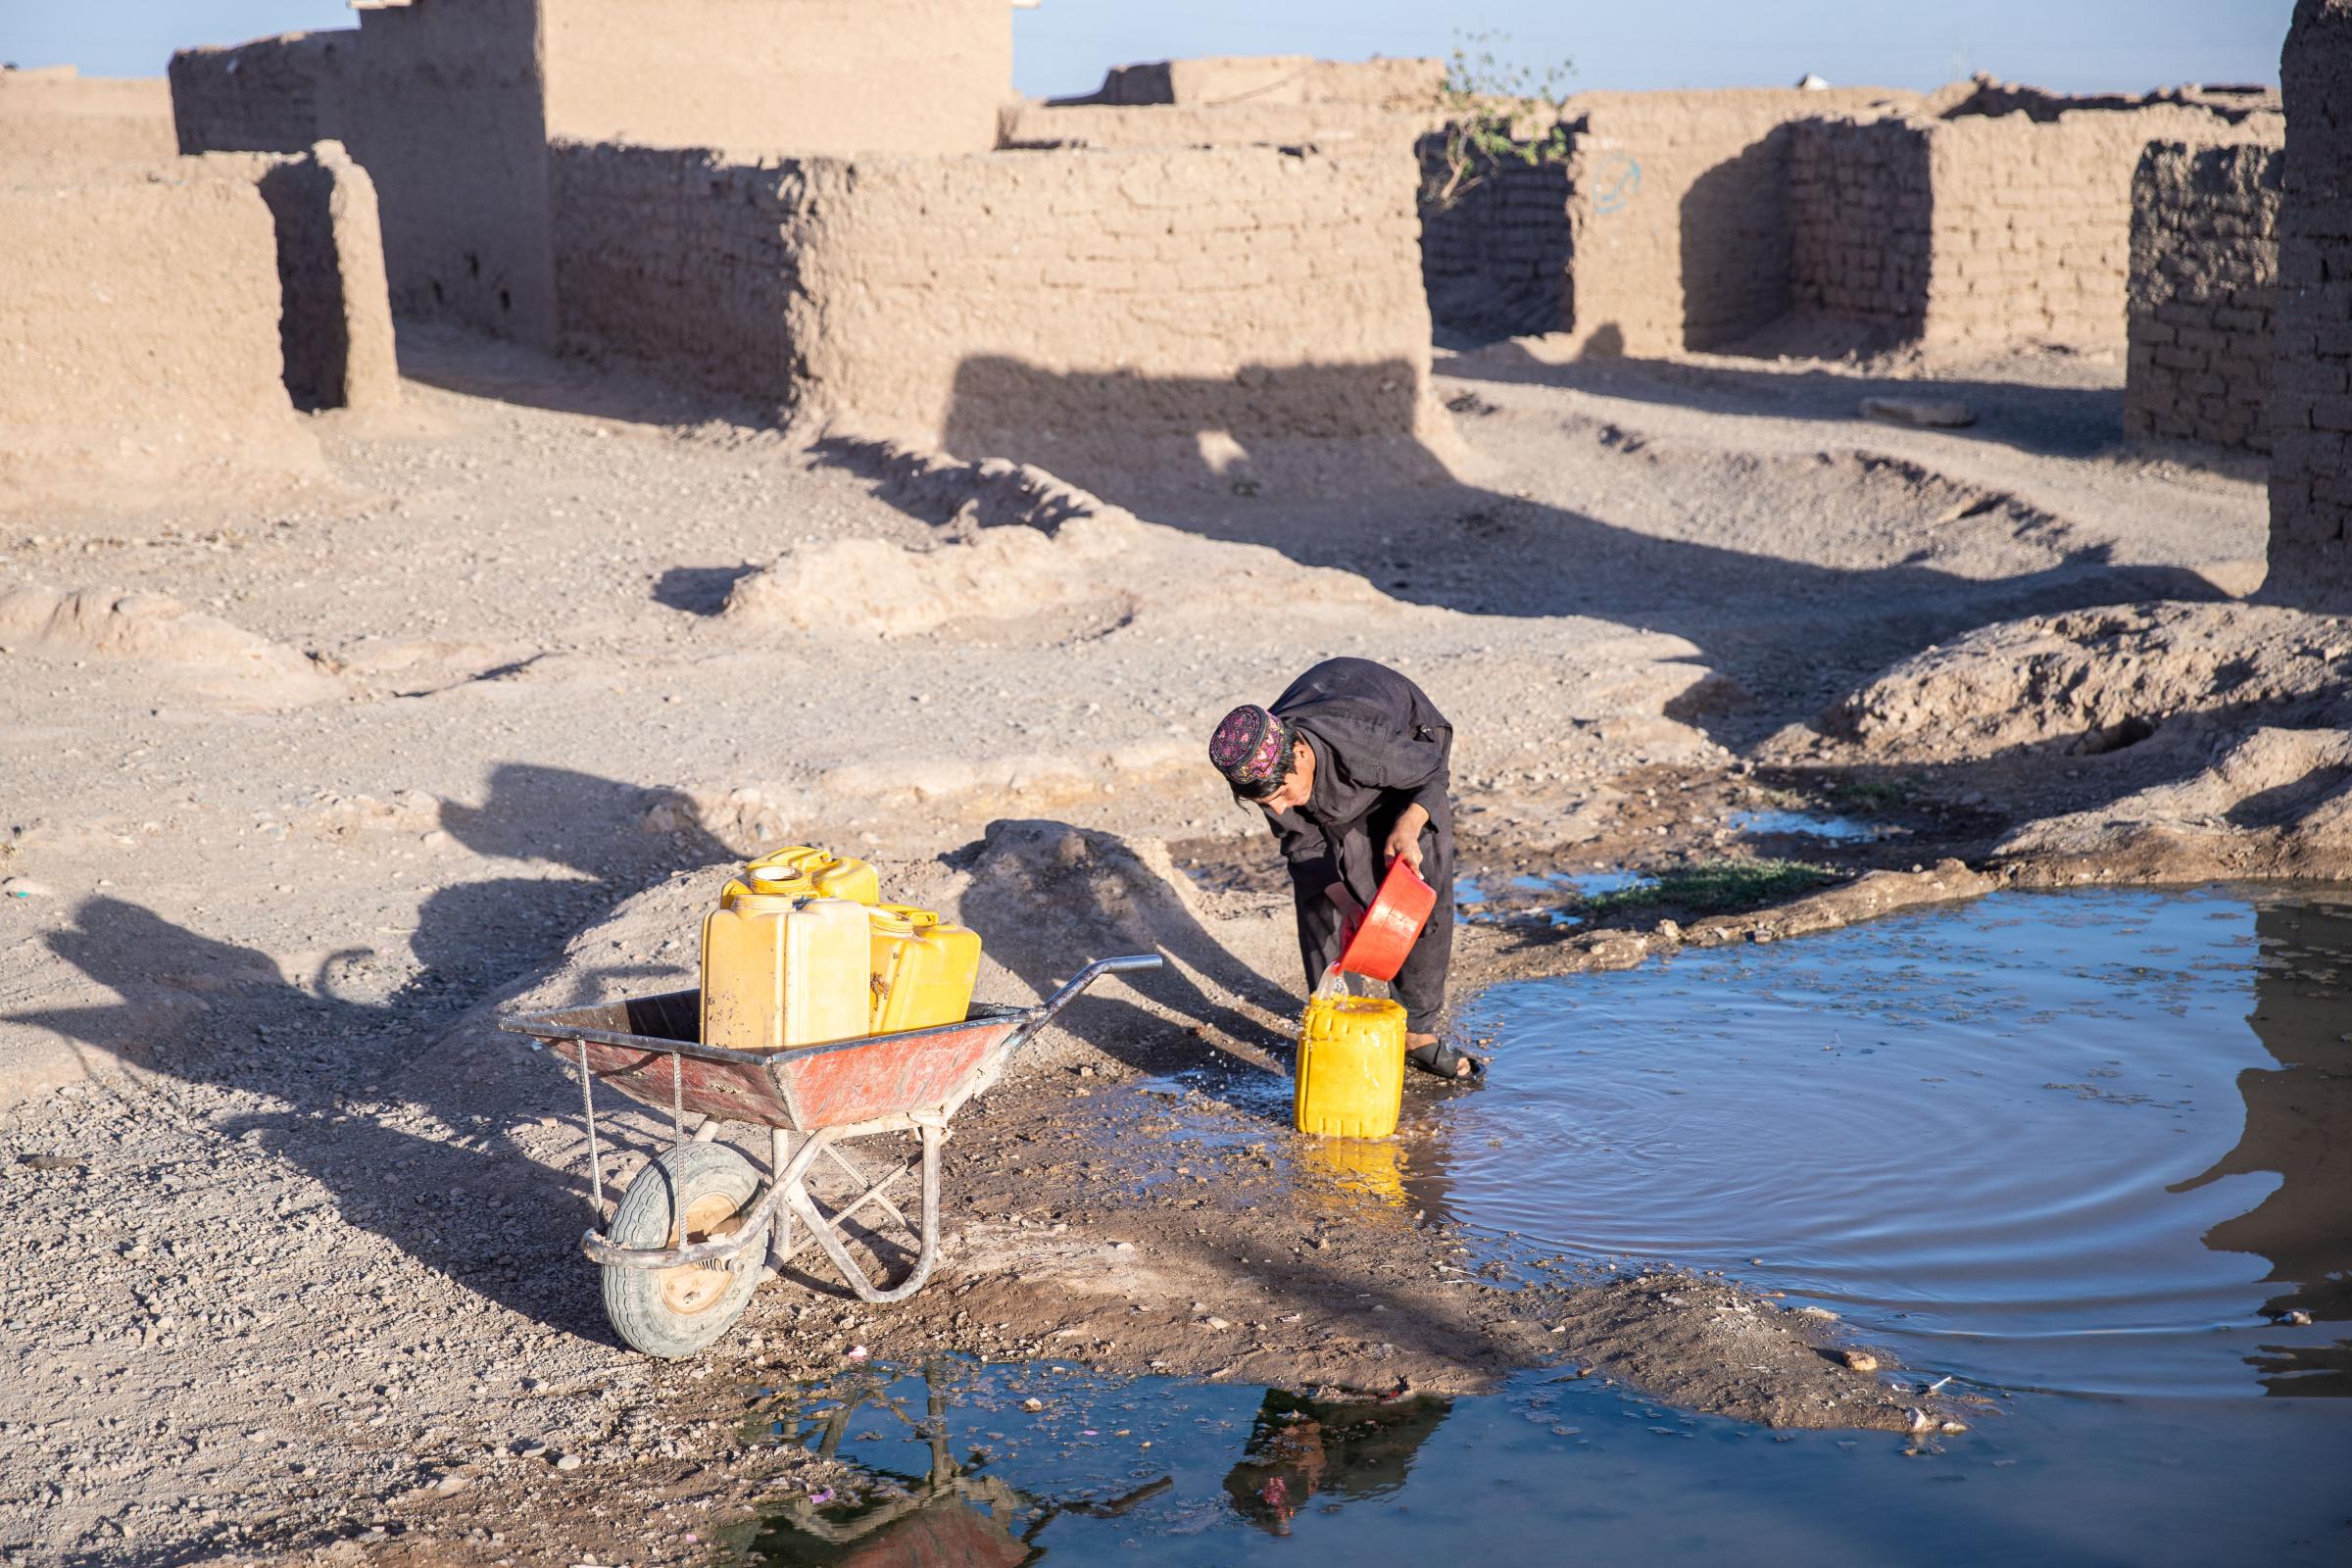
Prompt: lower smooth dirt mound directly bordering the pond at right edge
<box><xmin>1999</xmin><ymin>723</ymin><xmax>2352</xmax><ymax>882</ymax></box>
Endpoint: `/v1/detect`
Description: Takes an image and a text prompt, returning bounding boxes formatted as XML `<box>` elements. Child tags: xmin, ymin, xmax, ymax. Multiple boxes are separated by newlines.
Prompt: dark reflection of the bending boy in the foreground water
<box><xmin>1225</xmin><ymin>1387</ymin><xmax>1453</xmax><ymax>1535</ymax></box>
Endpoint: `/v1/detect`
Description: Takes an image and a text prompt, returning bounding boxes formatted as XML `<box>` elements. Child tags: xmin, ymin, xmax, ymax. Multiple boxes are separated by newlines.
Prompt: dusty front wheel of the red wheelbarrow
<box><xmin>605</xmin><ymin>1143</ymin><xmax>766</xmax><ymax>1361</ymax></box>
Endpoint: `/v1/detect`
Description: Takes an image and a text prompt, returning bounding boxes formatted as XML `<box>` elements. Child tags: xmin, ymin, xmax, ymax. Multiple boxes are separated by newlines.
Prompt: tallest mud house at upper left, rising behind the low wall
<box><xmin>172</xmin><ymin>0</ymin><xmax>1011</xmax><ymax>346</ymax></box>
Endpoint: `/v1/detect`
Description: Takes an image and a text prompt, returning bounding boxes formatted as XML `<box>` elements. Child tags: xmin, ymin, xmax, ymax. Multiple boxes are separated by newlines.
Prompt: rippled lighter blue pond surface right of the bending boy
<box><xmin>1409</xmin><ymin>891</ymin><xmax>2352</xmax><ymax>1394</ymax></box>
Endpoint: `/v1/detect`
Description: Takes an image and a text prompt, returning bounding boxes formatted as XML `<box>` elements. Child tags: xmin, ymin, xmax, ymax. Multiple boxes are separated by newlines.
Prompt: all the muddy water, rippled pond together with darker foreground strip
<box><xmin>722</xmin><ymin>889</ymin><xmax>2352</xmax><ymax>1566</ymax></box>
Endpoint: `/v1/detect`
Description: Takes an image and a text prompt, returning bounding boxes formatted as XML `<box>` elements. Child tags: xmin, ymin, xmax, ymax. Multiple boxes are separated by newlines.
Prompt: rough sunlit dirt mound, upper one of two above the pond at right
<box><xmin>1823</xmin><ymin>602</ymin><xmax>2352</xmax><ymax>761</ymax></box>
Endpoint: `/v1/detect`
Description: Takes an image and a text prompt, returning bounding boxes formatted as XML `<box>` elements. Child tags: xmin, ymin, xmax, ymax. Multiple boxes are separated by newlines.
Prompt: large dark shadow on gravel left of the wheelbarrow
<box><xmin>7</xmin><ymin>764</ymin><xmax>727</xmax><ymax>1343</ymax></box>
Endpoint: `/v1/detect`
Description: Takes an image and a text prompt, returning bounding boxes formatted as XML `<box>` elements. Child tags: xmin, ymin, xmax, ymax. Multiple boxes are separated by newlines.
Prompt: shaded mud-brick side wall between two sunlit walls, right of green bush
<box><xmin>1788</xmin><ymin>118</ymin><xmax>1936</xmax><ymax>338</ymax></box>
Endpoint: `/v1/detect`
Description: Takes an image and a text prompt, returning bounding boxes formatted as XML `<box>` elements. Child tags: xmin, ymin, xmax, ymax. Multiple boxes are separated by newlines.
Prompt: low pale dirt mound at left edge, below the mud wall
<box><xmin>0</xmin><ymin>588</ymin><xmax>343</xmax><ymax>708</ymax></box>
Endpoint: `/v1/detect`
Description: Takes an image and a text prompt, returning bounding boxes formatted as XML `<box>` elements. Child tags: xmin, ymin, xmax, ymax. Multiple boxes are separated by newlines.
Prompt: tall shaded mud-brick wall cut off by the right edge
<box><xmin>2263</xmin><ymin>0</ymin><xmax>2352</xmax><ymax>612</ymax></box>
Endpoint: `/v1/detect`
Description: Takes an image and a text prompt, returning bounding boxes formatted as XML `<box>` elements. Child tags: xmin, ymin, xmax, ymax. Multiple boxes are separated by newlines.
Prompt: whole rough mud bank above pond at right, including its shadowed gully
<box><xmin>1759</xmin><ymin>602</ymin><xmax>2352</xmax><ymax>884</ymax></box>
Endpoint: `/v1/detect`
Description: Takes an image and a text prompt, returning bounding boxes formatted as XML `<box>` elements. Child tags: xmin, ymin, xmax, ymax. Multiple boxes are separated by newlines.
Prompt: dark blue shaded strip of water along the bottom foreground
<box><xmin>733</xmin><ymin>1359</ymin><xmax>2352</xmax><ymax>1568</ymax></box>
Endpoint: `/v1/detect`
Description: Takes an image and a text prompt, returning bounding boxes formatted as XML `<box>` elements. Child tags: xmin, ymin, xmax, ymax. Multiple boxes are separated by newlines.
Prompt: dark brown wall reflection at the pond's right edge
<box><xmin>2174</xmin><ymin>903</ymin><xmax>2352</xmax><ymax>1394</ymax></box>
